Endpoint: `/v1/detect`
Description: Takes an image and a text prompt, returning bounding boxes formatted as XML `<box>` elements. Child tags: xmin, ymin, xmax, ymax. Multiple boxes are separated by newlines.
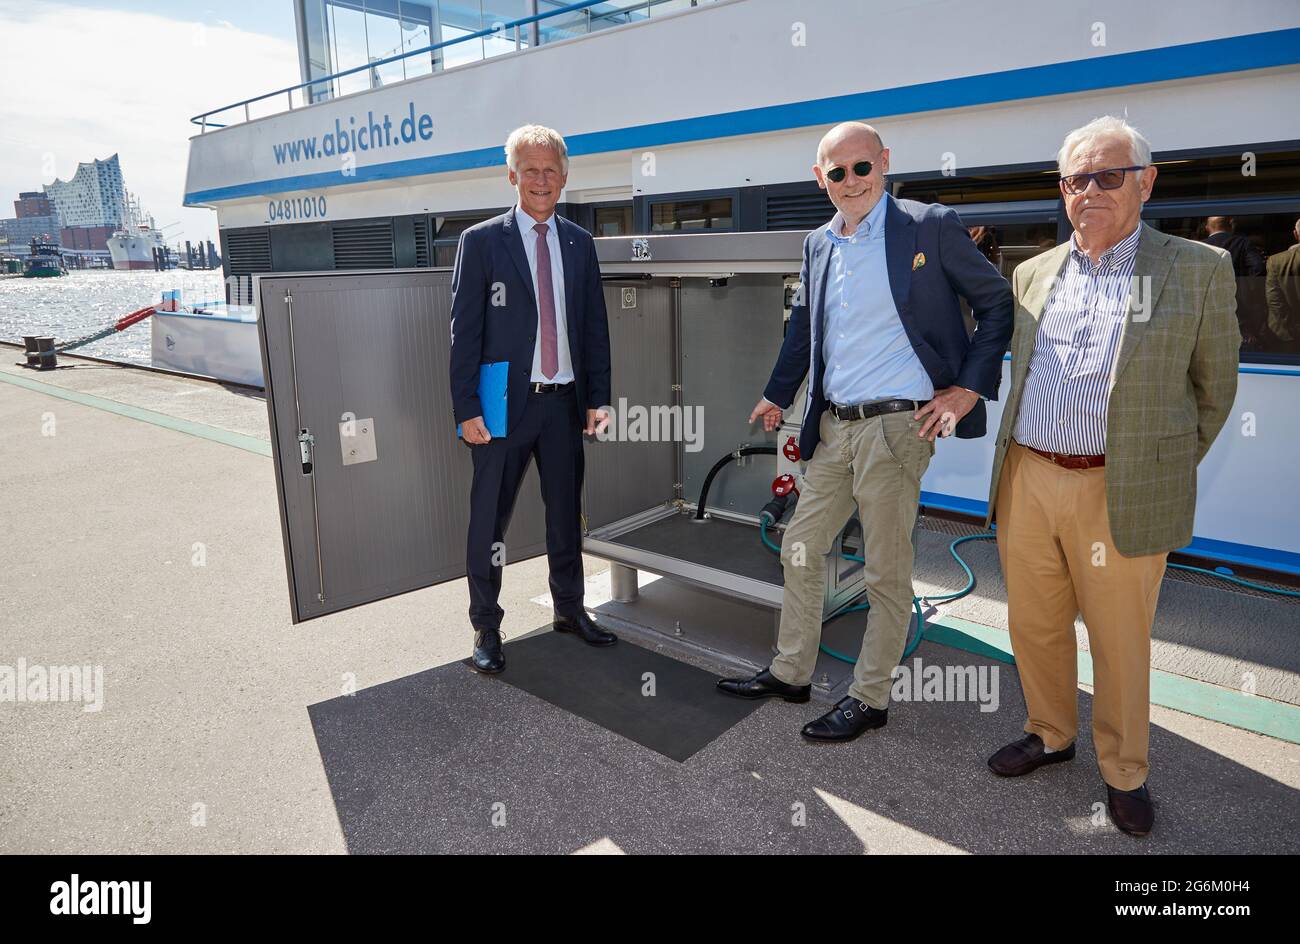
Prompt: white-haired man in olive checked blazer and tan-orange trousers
<box><xmin>985</xmin><ymin>117</ymin><xmax>1242</xmax><ymax>835</ymax></box>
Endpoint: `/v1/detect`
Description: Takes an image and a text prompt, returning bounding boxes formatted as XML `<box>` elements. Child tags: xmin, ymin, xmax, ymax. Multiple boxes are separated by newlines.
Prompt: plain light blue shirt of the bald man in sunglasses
<box><xmin>822</xmin><ymin>195</ymin><xmax>935</xmax><ymax>403</ymax></box>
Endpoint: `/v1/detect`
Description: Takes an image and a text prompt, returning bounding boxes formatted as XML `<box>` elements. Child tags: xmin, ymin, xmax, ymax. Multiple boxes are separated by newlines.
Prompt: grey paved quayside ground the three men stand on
<box><xmin>0</xmin><ymin>346</ymin><xmax>1300</xmax><ymax>853</ymax></box>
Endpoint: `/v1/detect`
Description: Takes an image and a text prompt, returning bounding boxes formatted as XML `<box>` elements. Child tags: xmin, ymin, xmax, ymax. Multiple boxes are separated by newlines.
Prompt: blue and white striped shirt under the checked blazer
<box><xmin>1013</xmin><ymin>224</ymin><xmax>1141</xmax><ymax>455</ymax></box>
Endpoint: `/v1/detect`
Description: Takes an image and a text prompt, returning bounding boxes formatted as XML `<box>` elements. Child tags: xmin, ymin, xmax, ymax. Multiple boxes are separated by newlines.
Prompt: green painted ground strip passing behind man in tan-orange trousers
<box><xmin>926</xmin><ymin>615</ymin><xmax>1300</xmax><ymax>744</ymax></box>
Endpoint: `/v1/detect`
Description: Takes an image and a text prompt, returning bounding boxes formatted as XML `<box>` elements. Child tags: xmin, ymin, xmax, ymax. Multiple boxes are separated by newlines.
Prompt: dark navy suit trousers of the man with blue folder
<box><xmin>465</xmin><ymin>385</ymin><xmax>582</xmax><ymax>629</ymax></box>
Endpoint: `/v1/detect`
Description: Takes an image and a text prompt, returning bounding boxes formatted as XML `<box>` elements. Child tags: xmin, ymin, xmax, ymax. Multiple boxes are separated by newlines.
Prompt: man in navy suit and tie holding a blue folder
<box><xmin>451</xmin><ymin>125</ymin><xmax>616</xmax><ymax>672</ymax></box>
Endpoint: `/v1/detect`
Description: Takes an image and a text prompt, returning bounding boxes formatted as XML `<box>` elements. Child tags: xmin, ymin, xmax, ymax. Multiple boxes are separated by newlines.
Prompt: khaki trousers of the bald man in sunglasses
<box><xmin>771</xmin><ymin>410</ymin><xmax>935</xmax><ymax>709</ymax></box>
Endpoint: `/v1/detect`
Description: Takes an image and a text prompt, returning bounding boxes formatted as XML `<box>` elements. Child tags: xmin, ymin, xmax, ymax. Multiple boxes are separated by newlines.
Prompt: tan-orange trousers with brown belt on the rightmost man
<box><xmin>996</xmin><ymin>439</ymin><xmax>1169</xmax><ymax>791</ymax></box>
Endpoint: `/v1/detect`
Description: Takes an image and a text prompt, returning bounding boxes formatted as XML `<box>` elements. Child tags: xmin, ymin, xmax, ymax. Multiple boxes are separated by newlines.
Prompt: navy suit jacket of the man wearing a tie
<box><xmin>451</xmin><ymin>207</ymin><xmax>610</xmax><ymax>433</ymax></box>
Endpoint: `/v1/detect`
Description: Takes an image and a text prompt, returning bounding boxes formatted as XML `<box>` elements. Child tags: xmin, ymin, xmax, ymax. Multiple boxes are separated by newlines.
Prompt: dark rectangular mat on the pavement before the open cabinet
<box><xmin>495</xmin><ymin>631</ymin><xmax>759</xmax><ymax>761</ymax></box>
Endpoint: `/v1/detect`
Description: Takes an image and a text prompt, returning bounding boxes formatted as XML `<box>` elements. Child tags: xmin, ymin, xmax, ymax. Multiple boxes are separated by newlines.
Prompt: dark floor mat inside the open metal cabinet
<box><xmin>608</xmin><ymin>515</ymin><xmax>785</xmax><ymax>586</ymax></box>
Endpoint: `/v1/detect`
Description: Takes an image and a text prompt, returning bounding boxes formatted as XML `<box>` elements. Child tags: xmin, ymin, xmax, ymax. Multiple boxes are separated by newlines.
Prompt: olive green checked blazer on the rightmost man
<box><xmin>984</xmin><ymin>224</ymin><xmax>1242</xmax><ymax>557</ymax></box>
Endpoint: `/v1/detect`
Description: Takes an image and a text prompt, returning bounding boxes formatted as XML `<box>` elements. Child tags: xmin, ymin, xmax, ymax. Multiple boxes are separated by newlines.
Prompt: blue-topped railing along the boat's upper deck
<box><xmin>190</xmin><ymin>0</ymin><xmax>702</xmax><ymax>134</ymax></box>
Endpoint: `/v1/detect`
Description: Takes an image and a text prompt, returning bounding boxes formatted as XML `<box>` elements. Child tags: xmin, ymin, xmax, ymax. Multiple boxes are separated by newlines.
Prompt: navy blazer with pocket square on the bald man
<box><xmin>763</xmin><ymin>194</ymin><xmax>1015</xmax><ymax>459</ymax></box>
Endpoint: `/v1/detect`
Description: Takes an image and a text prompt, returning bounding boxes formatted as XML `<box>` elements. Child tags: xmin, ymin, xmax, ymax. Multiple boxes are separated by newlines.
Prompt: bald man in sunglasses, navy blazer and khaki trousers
<box><xmin>718</xmin><ymin>122</ymin><xmax>1014</xmax><ymax>741</ymax></box>
